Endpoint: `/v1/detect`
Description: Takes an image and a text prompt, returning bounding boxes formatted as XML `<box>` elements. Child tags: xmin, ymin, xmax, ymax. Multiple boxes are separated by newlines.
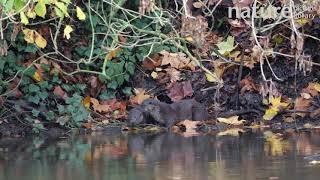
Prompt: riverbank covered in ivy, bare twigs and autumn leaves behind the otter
<box><xmin>0</xmin><ymin>0</ymin><xmax>320</xmax><ymax>134</ymax></box>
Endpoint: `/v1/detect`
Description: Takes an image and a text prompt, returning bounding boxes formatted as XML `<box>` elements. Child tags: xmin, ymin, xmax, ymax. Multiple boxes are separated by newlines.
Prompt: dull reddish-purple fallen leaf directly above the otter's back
<box><xmin>168</xmin><ymin>81</ymin><xmax>193</xmax><ymax>102</ymax></box>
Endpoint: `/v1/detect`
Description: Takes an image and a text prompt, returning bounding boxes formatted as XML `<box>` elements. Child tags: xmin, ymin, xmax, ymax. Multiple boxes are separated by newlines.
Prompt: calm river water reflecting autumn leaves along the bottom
<box><xmin>0</xmin><ymin>131</ymin><xmax>320</xmax><ymax>180</ymax></box>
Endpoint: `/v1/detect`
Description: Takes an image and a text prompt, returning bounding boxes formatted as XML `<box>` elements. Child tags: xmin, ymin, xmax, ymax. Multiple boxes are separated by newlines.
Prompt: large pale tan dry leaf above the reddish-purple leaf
<box><xmin>160</xmin><ymin>51</ymin><xmax>195</xmax><ymax>71</ymax></box>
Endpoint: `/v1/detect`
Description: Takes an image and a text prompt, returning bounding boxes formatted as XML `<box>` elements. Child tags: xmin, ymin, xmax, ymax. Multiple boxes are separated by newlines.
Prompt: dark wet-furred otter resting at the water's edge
<box><xmin>128</xmin><ymin>99</ymin><xmax>209</xmax><ymax>127</ymax></box>
